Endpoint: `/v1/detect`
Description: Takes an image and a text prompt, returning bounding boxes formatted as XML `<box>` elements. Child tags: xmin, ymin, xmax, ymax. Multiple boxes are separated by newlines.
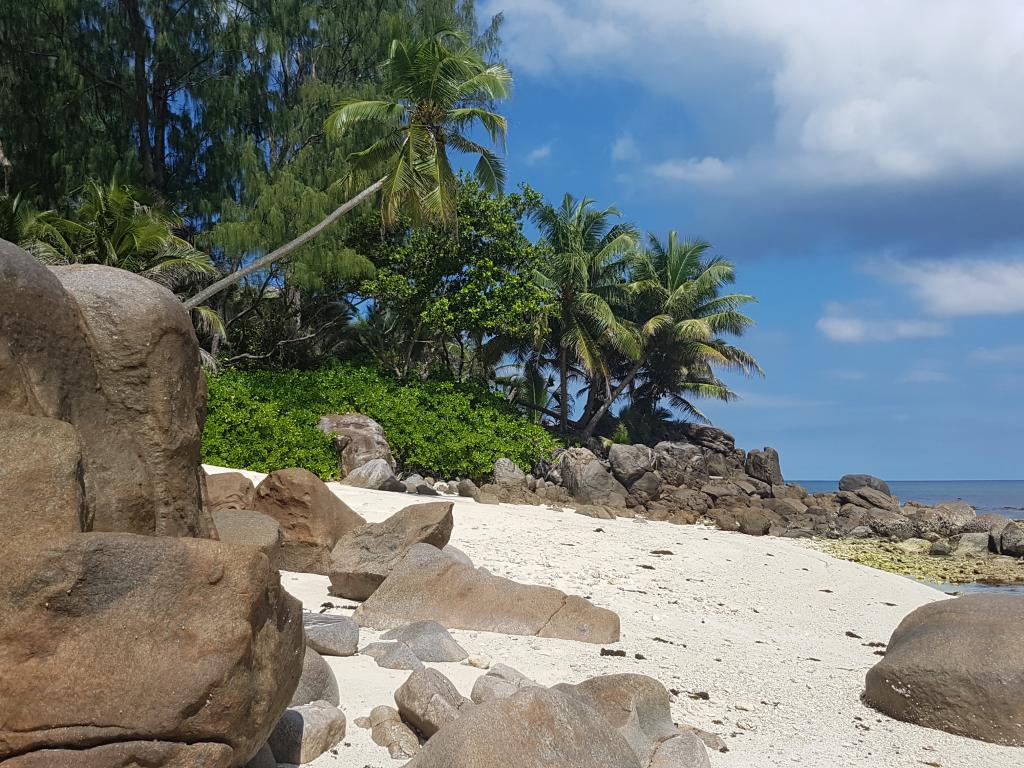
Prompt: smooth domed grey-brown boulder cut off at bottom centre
<box><xmin>407</xmin><ymin>687</ymin><xmax>647</xmax><ymax>768</ymax></box>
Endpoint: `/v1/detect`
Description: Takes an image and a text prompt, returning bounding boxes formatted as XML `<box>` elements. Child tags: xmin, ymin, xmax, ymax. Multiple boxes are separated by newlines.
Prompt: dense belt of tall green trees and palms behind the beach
<box><xmin>0</xmin><ymin>0</ymin><xmax>760</xmax><ymax>441</ymax></box>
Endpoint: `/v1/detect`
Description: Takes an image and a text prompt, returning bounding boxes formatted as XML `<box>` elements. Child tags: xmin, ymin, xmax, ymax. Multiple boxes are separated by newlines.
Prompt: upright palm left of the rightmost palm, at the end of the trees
<box><xmin>534</xmin><ymin>195</ymin><xmax>637</xmax><ymax>433</ymax></box>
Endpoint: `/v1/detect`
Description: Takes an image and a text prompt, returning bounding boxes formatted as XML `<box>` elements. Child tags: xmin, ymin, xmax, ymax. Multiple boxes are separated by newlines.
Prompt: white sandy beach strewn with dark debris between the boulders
<box><xmin>210</xmin><ymin>468</ymin><xmax>1024</xmax><ymax>768</ymax></box>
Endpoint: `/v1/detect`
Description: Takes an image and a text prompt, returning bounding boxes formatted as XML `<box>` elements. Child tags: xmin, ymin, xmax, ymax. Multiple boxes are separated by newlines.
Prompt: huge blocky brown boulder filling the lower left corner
<box><xmin>0</xmin><ymin>534</ymin><xmax>302</xmax><ymax>765</ymax></box>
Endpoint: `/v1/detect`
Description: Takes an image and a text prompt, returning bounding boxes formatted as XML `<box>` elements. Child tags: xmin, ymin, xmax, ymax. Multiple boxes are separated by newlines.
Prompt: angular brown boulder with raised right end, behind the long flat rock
<box><xmin>329</xmin><ymin>502</ymin><xmax>455</xmax><ymax>600</ymax></box>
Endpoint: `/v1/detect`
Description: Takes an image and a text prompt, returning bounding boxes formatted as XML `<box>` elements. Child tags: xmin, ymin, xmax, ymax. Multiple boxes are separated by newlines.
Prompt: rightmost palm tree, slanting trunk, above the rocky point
<box><xmin>582</xmin><ymin>231</ymin><xmax>762</xmax><ymax>439</ymax></box>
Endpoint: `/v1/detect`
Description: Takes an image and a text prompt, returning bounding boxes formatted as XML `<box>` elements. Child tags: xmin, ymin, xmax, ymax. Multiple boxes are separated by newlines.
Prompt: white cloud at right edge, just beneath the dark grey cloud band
<box><xmin>868</xmin><ymin>257</ymin><xmax>1024</xmax><ymax>317</ymax></box>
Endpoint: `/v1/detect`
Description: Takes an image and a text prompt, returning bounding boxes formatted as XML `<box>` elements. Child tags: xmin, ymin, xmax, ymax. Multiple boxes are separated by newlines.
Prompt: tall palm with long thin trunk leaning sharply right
<box><xmin>185</xmin><ymin>29</ymin><xmax>512</xmax><ymax>306</ymax></box>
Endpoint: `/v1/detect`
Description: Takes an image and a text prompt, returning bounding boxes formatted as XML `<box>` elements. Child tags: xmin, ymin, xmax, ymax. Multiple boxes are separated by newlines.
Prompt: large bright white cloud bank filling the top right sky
<box><xmin>485</xmin><ymin>0</ymin><xmax>1024</xmax><ymax>184</ymax></box>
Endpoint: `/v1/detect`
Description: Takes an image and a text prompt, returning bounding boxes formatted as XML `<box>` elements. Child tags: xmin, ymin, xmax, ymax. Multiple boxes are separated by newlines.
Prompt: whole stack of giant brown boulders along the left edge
<box><xmin>0</xmin><ymin>241</ymin><xmax>303</xmax><ymax>768</ymax></box>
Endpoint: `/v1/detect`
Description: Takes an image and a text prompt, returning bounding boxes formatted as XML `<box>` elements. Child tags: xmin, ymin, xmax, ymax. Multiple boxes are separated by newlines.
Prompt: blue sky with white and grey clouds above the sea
<box><xmin>481</xmin><ymin>0</ymin><xmax>1024</xmax><ymax>479</ymax></box>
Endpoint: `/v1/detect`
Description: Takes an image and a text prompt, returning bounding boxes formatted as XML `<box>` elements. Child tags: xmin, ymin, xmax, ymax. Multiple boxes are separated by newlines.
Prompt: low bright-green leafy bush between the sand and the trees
<box><xmin>203</xmin><ymin>365</ymin><xmax>556</xmax><ymax>479</ymax></box>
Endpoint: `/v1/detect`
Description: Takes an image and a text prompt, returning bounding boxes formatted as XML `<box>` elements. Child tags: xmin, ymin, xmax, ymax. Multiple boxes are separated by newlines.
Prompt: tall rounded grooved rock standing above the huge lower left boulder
<box><xmin>0</xmin><ymin>241</ymin><xmax>212</xmax><ymax>537</ymax></box>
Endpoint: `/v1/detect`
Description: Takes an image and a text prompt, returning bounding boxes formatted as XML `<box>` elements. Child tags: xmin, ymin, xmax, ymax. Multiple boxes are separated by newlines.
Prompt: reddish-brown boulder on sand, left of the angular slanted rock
<box><xmin>255</xmin><ymin>467</ymin><xmax>366</xmax><ymax>575</ymax></box>
